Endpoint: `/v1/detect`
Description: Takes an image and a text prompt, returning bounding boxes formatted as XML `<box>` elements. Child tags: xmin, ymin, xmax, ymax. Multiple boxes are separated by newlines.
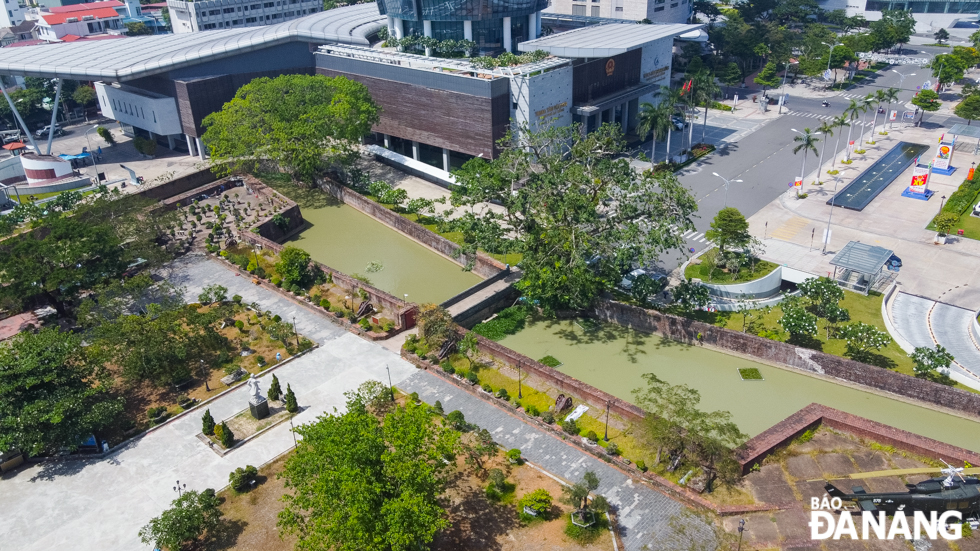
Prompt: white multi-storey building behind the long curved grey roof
<box><xmin>167</xmin><ymin>0</ymin><xmax>323</xmax><ymax>33</ymax></box>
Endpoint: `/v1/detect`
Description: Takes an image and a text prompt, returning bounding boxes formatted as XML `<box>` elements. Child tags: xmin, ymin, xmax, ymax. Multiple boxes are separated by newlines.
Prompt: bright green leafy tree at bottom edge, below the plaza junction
<box><xmin>279</xmin><ymin>393</ymin><xmax>459</xmax><ymax>551</ymax></box>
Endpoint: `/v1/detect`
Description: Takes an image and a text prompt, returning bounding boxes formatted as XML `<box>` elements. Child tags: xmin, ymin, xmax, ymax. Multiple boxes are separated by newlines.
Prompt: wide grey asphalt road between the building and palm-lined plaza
<box><xmin>658</xmin><ymin>47</ymin><xmax>966</xmax><ymax>272</ymax></box>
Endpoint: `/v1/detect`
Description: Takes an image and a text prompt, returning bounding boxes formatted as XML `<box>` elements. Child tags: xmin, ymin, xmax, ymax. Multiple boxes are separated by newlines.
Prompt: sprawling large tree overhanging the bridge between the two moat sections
<box><xmin>451</xmin><ymin>125</ymin><xmax>697</xmax><ymax>311</ymax></box>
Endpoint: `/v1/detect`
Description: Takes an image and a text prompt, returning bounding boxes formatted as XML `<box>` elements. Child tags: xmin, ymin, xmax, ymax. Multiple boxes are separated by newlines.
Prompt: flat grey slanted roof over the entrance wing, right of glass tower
<box><xmin>517</xmin><ymin>23</ymin><xmax>703</xmax><ymax>58</ymax></box>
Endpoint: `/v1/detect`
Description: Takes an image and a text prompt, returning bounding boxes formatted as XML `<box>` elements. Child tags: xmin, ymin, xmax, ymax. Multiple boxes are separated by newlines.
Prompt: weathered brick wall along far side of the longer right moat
<box><xmin>590</xmin><ymin>300</ymin><xmax>980</xmax><ymax>417</ymax></box>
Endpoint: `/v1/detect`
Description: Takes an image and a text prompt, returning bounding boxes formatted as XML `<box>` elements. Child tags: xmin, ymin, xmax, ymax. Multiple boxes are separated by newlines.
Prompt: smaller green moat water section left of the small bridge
<box><xmin>290</xmin><ymin>204</ymin><xmax>482</xmax><ymax>304</ymax></box>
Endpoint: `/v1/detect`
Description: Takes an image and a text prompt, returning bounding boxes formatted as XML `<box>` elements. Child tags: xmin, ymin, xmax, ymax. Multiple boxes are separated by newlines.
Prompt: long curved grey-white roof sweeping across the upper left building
<box><xmin>0</xmin><ymin>3</ymin><xmax>386</xmax><ymax>82</ymax></box>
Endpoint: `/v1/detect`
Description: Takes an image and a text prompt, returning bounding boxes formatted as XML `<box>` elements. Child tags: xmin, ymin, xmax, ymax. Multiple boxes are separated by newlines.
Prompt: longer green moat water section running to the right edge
<box><xmin>501</xmin><ymin>321</ymin><xmax>980</xmax><ymax>451</ymax></box>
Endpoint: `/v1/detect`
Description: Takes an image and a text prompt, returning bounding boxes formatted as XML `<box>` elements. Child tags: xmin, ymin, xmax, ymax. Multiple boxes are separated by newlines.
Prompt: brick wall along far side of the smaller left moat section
<box><xmin>318</xmin><ymin>179</ymin><xmax>505</xmax><ymax>278</ymax></box>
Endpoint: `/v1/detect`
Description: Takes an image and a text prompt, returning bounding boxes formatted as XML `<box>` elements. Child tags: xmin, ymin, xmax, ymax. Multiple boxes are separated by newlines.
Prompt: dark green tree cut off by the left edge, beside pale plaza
<box><xmin>0</xmin><ymin>328</ymin><xmax>122</xmax><ymax>455</ymax></box>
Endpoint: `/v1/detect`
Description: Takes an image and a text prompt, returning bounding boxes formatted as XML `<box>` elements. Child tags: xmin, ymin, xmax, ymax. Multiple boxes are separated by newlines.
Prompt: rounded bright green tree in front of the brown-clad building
<box><xmin>202</xmin><ymin>75</ymin><xmax>379</xmax><ymax>182</ymax></box>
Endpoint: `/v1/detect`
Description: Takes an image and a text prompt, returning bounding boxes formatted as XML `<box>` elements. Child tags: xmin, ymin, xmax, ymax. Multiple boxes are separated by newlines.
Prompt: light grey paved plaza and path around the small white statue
<box><xmin>0</xmin><ymin>257</ymin><xmax>416</xmax><ymax>551</ymax></box>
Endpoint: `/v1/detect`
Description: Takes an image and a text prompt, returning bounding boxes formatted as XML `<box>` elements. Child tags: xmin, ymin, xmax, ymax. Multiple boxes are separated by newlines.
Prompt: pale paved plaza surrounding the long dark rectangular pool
<box><xmin>749</xmin><ymin>118</ymin><xmax>980</xmax><ymax>311</ymax></box>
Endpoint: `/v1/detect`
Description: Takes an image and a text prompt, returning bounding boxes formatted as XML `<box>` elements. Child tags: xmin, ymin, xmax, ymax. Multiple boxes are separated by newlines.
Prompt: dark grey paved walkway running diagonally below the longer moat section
<box><xmin>398</xmin><ymin>371</ymin><xmax>710</xmax><ymax>551</ymax></box>
